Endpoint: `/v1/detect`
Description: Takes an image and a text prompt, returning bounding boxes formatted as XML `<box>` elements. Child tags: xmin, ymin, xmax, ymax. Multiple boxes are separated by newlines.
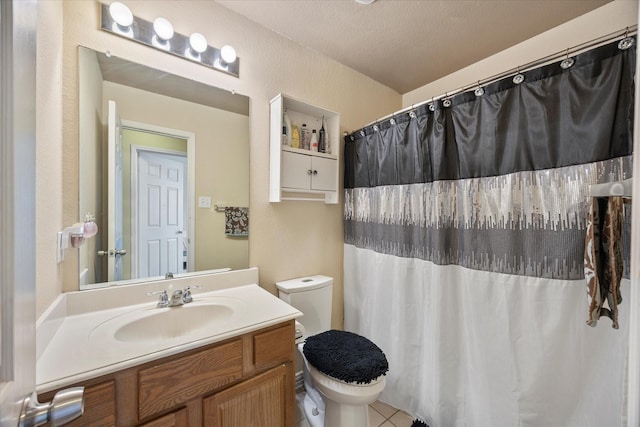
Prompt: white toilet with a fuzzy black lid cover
<box><xmin>276</xmin><ymin>276</ymin><xmax>388</xmax><ymax>427</ymax></box>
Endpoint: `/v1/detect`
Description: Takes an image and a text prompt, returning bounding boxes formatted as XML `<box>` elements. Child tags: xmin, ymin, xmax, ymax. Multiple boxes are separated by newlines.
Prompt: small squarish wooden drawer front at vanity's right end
<box><xmin>253</xmin><ymin>321</ymin><xmax>295</xmax><ymax>369</ymax></box>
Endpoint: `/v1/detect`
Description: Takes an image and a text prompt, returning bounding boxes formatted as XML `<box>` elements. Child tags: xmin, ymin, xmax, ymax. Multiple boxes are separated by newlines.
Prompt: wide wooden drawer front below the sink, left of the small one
<box><xmin>138</xmin><ymin>339</ymin><xmax>242</xmax><ymax>419</ymax></box>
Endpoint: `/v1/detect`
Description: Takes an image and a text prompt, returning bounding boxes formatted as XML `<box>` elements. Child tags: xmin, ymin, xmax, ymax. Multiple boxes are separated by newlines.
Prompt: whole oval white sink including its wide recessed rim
<box><xmin>89</xmin><ymin>297</ymin><xmax>243</xmax><ymax>344</ymax></box>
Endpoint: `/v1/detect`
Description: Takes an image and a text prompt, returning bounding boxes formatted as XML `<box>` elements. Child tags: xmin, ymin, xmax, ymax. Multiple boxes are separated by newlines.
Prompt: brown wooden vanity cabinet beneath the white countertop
<box><xmin>39</xmin><ymin>320</ymin><xmax>295</xmax><ymax>427</ymax></box>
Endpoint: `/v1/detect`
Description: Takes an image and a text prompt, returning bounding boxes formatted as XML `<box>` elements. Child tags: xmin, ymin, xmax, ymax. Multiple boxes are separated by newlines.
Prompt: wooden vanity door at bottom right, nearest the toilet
<box><xmin>203</xmin><ymin>363</ymin><xmax>295</xmax><ymax>427</ymax></box>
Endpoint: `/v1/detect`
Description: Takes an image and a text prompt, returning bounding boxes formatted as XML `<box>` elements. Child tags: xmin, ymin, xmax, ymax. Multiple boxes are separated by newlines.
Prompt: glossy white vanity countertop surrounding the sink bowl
<box><xmin>36</xmin><ymin>278</ymin><xmax>302</xmax><ymax>393</ymax></box>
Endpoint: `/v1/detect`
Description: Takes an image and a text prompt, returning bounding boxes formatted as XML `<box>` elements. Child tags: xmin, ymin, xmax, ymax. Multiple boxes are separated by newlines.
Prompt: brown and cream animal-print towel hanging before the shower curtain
<box><xmin>584</xmin><ymin>197</ymin><xmax>623</xmax><ymax>329</ymax></box>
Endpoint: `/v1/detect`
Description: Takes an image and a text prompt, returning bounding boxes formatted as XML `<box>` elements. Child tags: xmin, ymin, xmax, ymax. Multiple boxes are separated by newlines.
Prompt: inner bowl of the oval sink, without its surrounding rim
<box><xmin>113</xmin><ymin>304</ymin><xmax>234</xmax><ymax>342</ymax></box>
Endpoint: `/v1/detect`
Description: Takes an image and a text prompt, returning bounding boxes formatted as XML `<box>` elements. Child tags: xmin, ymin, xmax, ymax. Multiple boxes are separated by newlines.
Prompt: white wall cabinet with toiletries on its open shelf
<box><xmin>269</xmin><ymin>94</ymin><xmax>340</xmax><ymax>204</ymax></box>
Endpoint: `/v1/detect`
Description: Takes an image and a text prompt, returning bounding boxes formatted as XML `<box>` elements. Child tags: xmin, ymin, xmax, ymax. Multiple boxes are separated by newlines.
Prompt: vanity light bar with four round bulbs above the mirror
<box><xmin>100</xmin><ymin>2</ymin><xmax>240</xmax><ymax>77</ymax></box>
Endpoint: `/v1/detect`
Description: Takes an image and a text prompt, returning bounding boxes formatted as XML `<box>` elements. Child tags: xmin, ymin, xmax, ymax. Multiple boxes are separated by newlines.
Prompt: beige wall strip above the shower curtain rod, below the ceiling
<box><xmin>402</xmin><ymin>0</ymin><xmax>638</xmax><ymax>108</ymax></box>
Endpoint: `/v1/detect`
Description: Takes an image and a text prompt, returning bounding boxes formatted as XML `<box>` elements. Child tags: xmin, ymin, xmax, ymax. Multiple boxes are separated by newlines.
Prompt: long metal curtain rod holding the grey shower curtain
<box><xmin>362</xmin><ymin>25</ymin><xmax>638</xmax><ymax>128</ymax></box>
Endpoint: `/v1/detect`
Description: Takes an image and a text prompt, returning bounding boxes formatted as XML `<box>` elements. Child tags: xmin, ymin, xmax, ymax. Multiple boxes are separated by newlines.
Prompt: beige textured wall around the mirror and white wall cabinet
<box><xmin>37</xmin><ymin>0</ymin><xmax>401</xmax><ymax>332</ymax></box>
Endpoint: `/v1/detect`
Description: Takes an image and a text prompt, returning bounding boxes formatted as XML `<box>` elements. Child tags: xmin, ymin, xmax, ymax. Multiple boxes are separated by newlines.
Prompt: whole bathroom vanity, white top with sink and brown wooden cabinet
<box><xmin>37</xmin><ymin>272</ymin><xmax>300</xmax><ymax>427</ymax></box>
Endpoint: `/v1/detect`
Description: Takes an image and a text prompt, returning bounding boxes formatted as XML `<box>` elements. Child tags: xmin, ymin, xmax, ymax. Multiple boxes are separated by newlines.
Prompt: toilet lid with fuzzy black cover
<box><xmin>303</xmin><ymin>329</ymin><xmax>389</xmax><ymax>384</ymax></box>
